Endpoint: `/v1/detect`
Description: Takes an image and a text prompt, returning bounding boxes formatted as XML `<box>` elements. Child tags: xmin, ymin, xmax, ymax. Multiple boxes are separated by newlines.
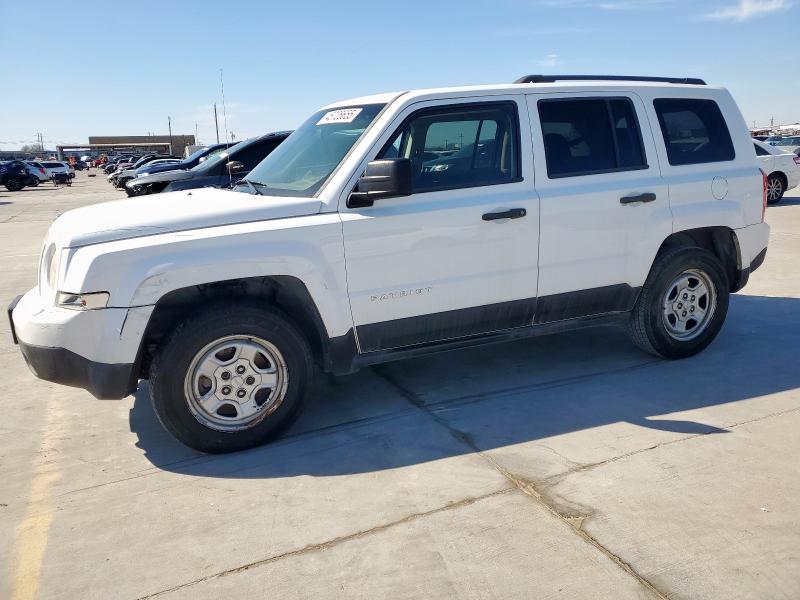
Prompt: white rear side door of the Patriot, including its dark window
<box><xmin>527</xmin><ymin>92</ymin><xmax>672</xmax><ymax>323</ymax></box>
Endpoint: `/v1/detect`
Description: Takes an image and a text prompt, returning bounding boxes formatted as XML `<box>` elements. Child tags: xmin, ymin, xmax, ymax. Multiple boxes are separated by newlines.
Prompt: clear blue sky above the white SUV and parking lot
<box><xmin>0</xmin><ymin>0</ymin><xmax>800</xmax><ymax>149</ymax></box>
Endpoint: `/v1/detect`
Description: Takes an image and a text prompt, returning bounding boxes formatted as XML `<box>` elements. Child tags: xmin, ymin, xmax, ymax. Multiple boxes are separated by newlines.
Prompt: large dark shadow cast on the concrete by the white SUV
<box><xmin>130</xmin><ymin>295</ymin><xmax>800</xmax><ymax>478</ymax></box>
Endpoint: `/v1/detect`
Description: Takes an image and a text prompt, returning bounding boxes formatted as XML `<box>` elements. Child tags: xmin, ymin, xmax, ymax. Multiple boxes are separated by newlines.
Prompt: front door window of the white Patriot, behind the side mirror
<box><xmin>378</xmin><ymin>102</ymin><xmax>520</xmax><ymax>191</ymax></box>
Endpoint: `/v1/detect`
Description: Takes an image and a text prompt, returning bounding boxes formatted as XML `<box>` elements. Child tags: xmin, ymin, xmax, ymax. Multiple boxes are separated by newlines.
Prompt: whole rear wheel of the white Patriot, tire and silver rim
<box><xmin>628</xmin><ymin>247</ymin><xmax>730</xmax><ymax>359</ymax></box>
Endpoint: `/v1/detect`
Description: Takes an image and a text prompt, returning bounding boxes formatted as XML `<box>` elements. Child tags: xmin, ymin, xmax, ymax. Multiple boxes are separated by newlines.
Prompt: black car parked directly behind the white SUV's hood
<box><xmin>125</xmin><ymin>131</ymin><xmax>291</xmax><ymax>196</ymax></box>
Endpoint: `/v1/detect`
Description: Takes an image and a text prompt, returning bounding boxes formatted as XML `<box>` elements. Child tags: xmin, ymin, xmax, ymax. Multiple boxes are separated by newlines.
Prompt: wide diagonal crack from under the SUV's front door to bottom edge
<box><xmin>373</xmin><ymin>367</ymin><xmax>669</xmax><ymax>600</ymax></box>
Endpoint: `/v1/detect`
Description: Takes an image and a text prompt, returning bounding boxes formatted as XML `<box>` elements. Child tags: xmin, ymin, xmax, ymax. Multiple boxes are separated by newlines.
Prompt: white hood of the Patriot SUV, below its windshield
<box><xmin>48</xmin><ymin>188</ymin><xmax>321</xmax><ymax>248</ymax></box>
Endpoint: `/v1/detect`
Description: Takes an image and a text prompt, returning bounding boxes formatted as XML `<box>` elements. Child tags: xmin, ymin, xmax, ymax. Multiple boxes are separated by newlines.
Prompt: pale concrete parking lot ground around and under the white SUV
<box><xmin>0</xmin><ymin>173</ymin><xmax>800</xmax><ymax>600</ymax></box>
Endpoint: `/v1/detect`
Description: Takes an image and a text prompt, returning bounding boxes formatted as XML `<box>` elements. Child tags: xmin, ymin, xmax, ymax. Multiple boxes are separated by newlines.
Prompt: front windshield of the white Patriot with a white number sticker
<box><xmin>245</xmin><ymin>104</ymin><xmax>385</xmax><ymax>197</ymax></box>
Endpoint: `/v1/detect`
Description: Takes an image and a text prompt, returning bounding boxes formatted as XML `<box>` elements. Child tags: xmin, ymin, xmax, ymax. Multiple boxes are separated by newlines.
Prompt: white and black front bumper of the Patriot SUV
<box><xmin>8</xmin><ymin>289</ymin><xmax>152</xmax><ymax>399</ymax></box>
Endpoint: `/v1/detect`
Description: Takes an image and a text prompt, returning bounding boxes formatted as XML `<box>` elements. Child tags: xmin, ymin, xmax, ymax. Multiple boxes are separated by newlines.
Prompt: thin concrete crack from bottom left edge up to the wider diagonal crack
<box><xmin>137</xmin><ymin>487</ymin><xmax>517</xmax><ymax>600</ymax></box>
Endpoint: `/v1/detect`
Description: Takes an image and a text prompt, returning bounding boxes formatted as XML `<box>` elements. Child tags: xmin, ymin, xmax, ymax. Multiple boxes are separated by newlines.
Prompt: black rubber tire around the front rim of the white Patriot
<box><xmin>150</xmin><ymin>303</ymin><xmax>314</xmax><ymax>453</ymax></box>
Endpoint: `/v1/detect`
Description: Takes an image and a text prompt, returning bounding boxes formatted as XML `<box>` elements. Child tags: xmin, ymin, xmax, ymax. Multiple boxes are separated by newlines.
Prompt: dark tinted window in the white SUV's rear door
<box><xmin>538</xmin><ymin>98</ymin><xmax>647</xmax><ymax>179</ymax></box>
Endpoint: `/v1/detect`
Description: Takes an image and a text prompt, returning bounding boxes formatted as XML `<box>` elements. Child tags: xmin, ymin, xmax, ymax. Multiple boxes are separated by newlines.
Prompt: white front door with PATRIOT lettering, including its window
<box><xmin>340</xmin><ymin>96</ymin><xmax>539</xmax><ymax>352</ymax></box>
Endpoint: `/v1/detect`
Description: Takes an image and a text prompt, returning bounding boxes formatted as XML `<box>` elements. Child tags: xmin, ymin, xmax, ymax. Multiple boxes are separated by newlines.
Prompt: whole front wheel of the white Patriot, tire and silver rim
<box><xmin>150</xmin><ymin>304</ymin><xmax>313</xmax><ymax>453</ymax></box>
